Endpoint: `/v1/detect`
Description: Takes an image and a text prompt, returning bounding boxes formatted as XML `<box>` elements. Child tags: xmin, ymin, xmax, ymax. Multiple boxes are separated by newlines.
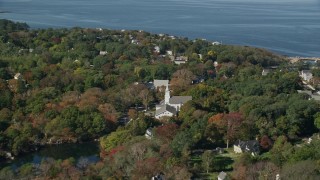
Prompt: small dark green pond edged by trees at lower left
<box><xmin>0</xmin><ymin>142</ymin><xmax>100</xmax><ymax>169</ymax></box>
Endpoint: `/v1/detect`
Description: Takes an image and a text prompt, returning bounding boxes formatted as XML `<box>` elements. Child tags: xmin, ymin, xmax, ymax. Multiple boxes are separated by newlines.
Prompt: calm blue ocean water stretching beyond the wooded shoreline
<box><xmin>0</xmin><ymin>0</ymin><xmax>320</xmax><ymax>57</ymax></box>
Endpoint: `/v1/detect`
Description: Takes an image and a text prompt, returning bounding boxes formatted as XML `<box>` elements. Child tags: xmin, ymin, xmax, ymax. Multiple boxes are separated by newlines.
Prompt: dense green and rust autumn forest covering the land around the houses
<box><xmin>0</xmin><ymin>20</ymin><xmax>320</xmax><ymax>179</ymax></box>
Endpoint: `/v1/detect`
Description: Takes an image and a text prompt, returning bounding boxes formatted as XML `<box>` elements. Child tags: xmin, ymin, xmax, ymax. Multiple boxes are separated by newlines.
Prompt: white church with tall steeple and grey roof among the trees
<box><xmin>155</xmin><ymin>85</ymin><xmax>192</xmax><ymax>119</ymax></box>
